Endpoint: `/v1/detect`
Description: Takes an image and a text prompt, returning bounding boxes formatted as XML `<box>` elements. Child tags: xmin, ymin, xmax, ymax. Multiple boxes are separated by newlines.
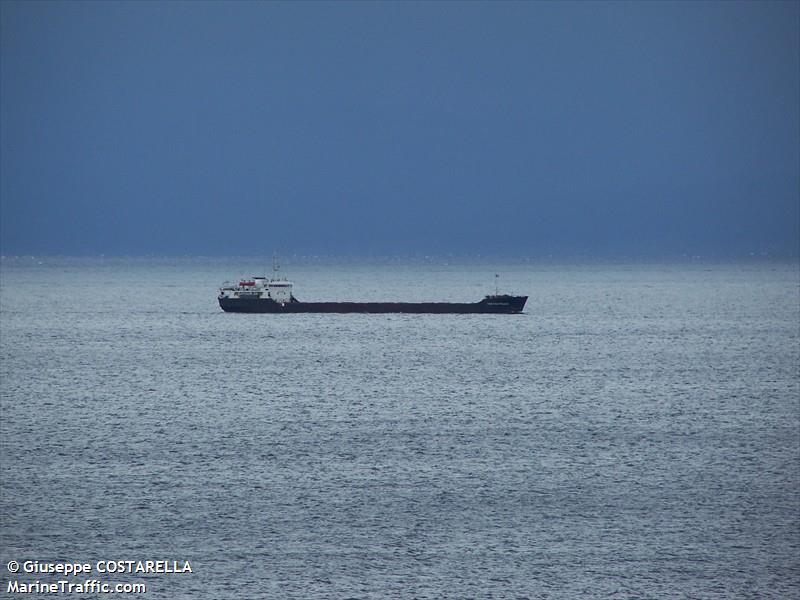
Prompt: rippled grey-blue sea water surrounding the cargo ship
<box><xmin>0</xmin><ymin>257</ymin><xmax>800</xmax><ymax>599</ymax></box>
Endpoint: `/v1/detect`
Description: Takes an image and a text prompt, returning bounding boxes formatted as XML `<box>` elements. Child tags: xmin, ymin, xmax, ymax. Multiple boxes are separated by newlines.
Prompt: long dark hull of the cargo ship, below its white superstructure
<box><xmin>219</xmin><ymin>296</ymin><xmax>528</xmax><ymax>314</ymax></box>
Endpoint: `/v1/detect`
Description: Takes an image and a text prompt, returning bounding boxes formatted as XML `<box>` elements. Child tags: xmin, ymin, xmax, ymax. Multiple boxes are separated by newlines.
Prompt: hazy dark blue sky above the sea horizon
<box><xmin>0</xmin><ymin>1</ymin><xmax>800</xmax><ymax>256</ymax></box>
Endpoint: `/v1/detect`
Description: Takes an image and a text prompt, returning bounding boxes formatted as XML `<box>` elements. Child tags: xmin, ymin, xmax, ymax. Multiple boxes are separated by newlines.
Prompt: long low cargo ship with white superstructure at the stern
<box><xmin>217</xmin><ymin>277</ymin><xmax>528</xmax><ymax>314</ymax></box>
